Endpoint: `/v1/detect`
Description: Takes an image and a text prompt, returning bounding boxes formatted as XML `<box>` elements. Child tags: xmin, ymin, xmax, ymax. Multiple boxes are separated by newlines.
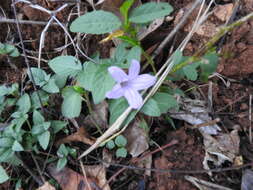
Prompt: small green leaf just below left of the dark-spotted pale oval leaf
<box><xmin>28</xmin><ymin>67</ymin><xmax>47</xmax><ymax>87</ymax></box>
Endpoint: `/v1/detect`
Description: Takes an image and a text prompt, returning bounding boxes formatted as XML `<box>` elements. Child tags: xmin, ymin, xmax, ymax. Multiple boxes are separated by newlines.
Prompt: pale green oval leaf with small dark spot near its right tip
<box><xmin>48</xmin><ymin>56</ymin><xmax>82</xmax><ymax>76</ymax></box>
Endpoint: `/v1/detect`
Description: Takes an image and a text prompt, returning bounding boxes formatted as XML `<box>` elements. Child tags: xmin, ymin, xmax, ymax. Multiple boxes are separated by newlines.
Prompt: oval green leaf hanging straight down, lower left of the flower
<box><xmin>61</xmin><ymin>87</ymin><xmax>82</xmax><ymax>118</ymax></box>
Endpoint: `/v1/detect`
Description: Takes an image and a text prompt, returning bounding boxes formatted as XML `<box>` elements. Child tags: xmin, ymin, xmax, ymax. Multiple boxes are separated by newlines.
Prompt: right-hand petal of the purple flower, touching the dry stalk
<box><xmin>128</xmin><ymin>74</ymin><xmax>156</xmax><ymax>90</ymax></box>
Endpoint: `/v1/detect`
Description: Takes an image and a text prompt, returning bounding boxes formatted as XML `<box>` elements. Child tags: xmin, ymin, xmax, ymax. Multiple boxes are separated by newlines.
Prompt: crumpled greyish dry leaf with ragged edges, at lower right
<box><xmin>203</xmin><ymin>129</ymin><xmax>240</xmax><ymax>169</ymax></box>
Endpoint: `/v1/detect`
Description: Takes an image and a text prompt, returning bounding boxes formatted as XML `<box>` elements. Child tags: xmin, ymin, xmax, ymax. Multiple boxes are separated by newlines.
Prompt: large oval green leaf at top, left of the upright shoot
<box><xmin>70</xmin><ymin>10</ymin><xmax>121</xmax><ymax>34</ymax></box>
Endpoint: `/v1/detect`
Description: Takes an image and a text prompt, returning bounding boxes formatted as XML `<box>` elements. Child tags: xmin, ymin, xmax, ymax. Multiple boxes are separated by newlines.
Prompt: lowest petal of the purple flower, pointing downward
<box><xmin>124</xmin><ymin>88</ymin><xmax>143</xmax><ymax>109</ymax></box>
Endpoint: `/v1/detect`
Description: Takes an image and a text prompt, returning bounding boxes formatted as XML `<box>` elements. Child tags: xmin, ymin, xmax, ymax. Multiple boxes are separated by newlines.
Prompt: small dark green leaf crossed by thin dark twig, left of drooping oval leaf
<box><xmin>31</xmin><ymin>90</ymin><xmax>49</xmax><ymax>109</ymax></box>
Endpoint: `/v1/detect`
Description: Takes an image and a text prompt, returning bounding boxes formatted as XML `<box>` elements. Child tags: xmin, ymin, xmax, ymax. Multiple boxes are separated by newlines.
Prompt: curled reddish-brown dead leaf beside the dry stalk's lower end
<box><xmin>56</xmin><ymin>127</ymin><xmax>96</xmax><ymax>146</ymax></box>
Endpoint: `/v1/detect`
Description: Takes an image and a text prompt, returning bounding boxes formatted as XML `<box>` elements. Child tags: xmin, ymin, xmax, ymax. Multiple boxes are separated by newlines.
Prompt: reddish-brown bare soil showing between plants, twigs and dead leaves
<box><xmin>0</xmin><ymin>0</ymin><xmax>253</xmax><ymax>190</ymax></box>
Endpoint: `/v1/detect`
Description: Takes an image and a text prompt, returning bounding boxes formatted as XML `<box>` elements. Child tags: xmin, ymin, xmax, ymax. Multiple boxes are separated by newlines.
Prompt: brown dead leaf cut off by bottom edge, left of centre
<box><xmin>47</xmin><ymin>164</ymin><xmax>105</xmax><ymax>190</ymax></box>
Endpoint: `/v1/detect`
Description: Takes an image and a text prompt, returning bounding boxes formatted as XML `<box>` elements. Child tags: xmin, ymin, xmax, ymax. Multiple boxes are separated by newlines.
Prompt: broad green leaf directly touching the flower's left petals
<box><xmin>92</xmin><ymin>65</ymin><xmax>115</xmax><ymax>104</ymax></box>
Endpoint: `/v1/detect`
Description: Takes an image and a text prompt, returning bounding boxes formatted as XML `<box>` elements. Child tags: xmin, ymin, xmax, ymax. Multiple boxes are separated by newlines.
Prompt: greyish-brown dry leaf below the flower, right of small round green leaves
<box><xmin>124</xmin><ymin>119</ymin><xmax>149</xmax><ymax>157</ymax></box>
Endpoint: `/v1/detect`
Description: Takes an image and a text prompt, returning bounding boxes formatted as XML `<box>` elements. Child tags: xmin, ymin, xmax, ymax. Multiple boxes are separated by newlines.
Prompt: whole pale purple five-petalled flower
<box><xmin>106</xmin><ymin>60</ymin><xmax>156</xmax><ymax>109</ymax></box>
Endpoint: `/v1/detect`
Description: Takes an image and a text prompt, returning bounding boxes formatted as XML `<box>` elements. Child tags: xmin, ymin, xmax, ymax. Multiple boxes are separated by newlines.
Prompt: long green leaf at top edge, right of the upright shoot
<box><xmin>129</xmin><ymin>2</ymin><xmax>173</xmax><ymax>23</ymax></box>
